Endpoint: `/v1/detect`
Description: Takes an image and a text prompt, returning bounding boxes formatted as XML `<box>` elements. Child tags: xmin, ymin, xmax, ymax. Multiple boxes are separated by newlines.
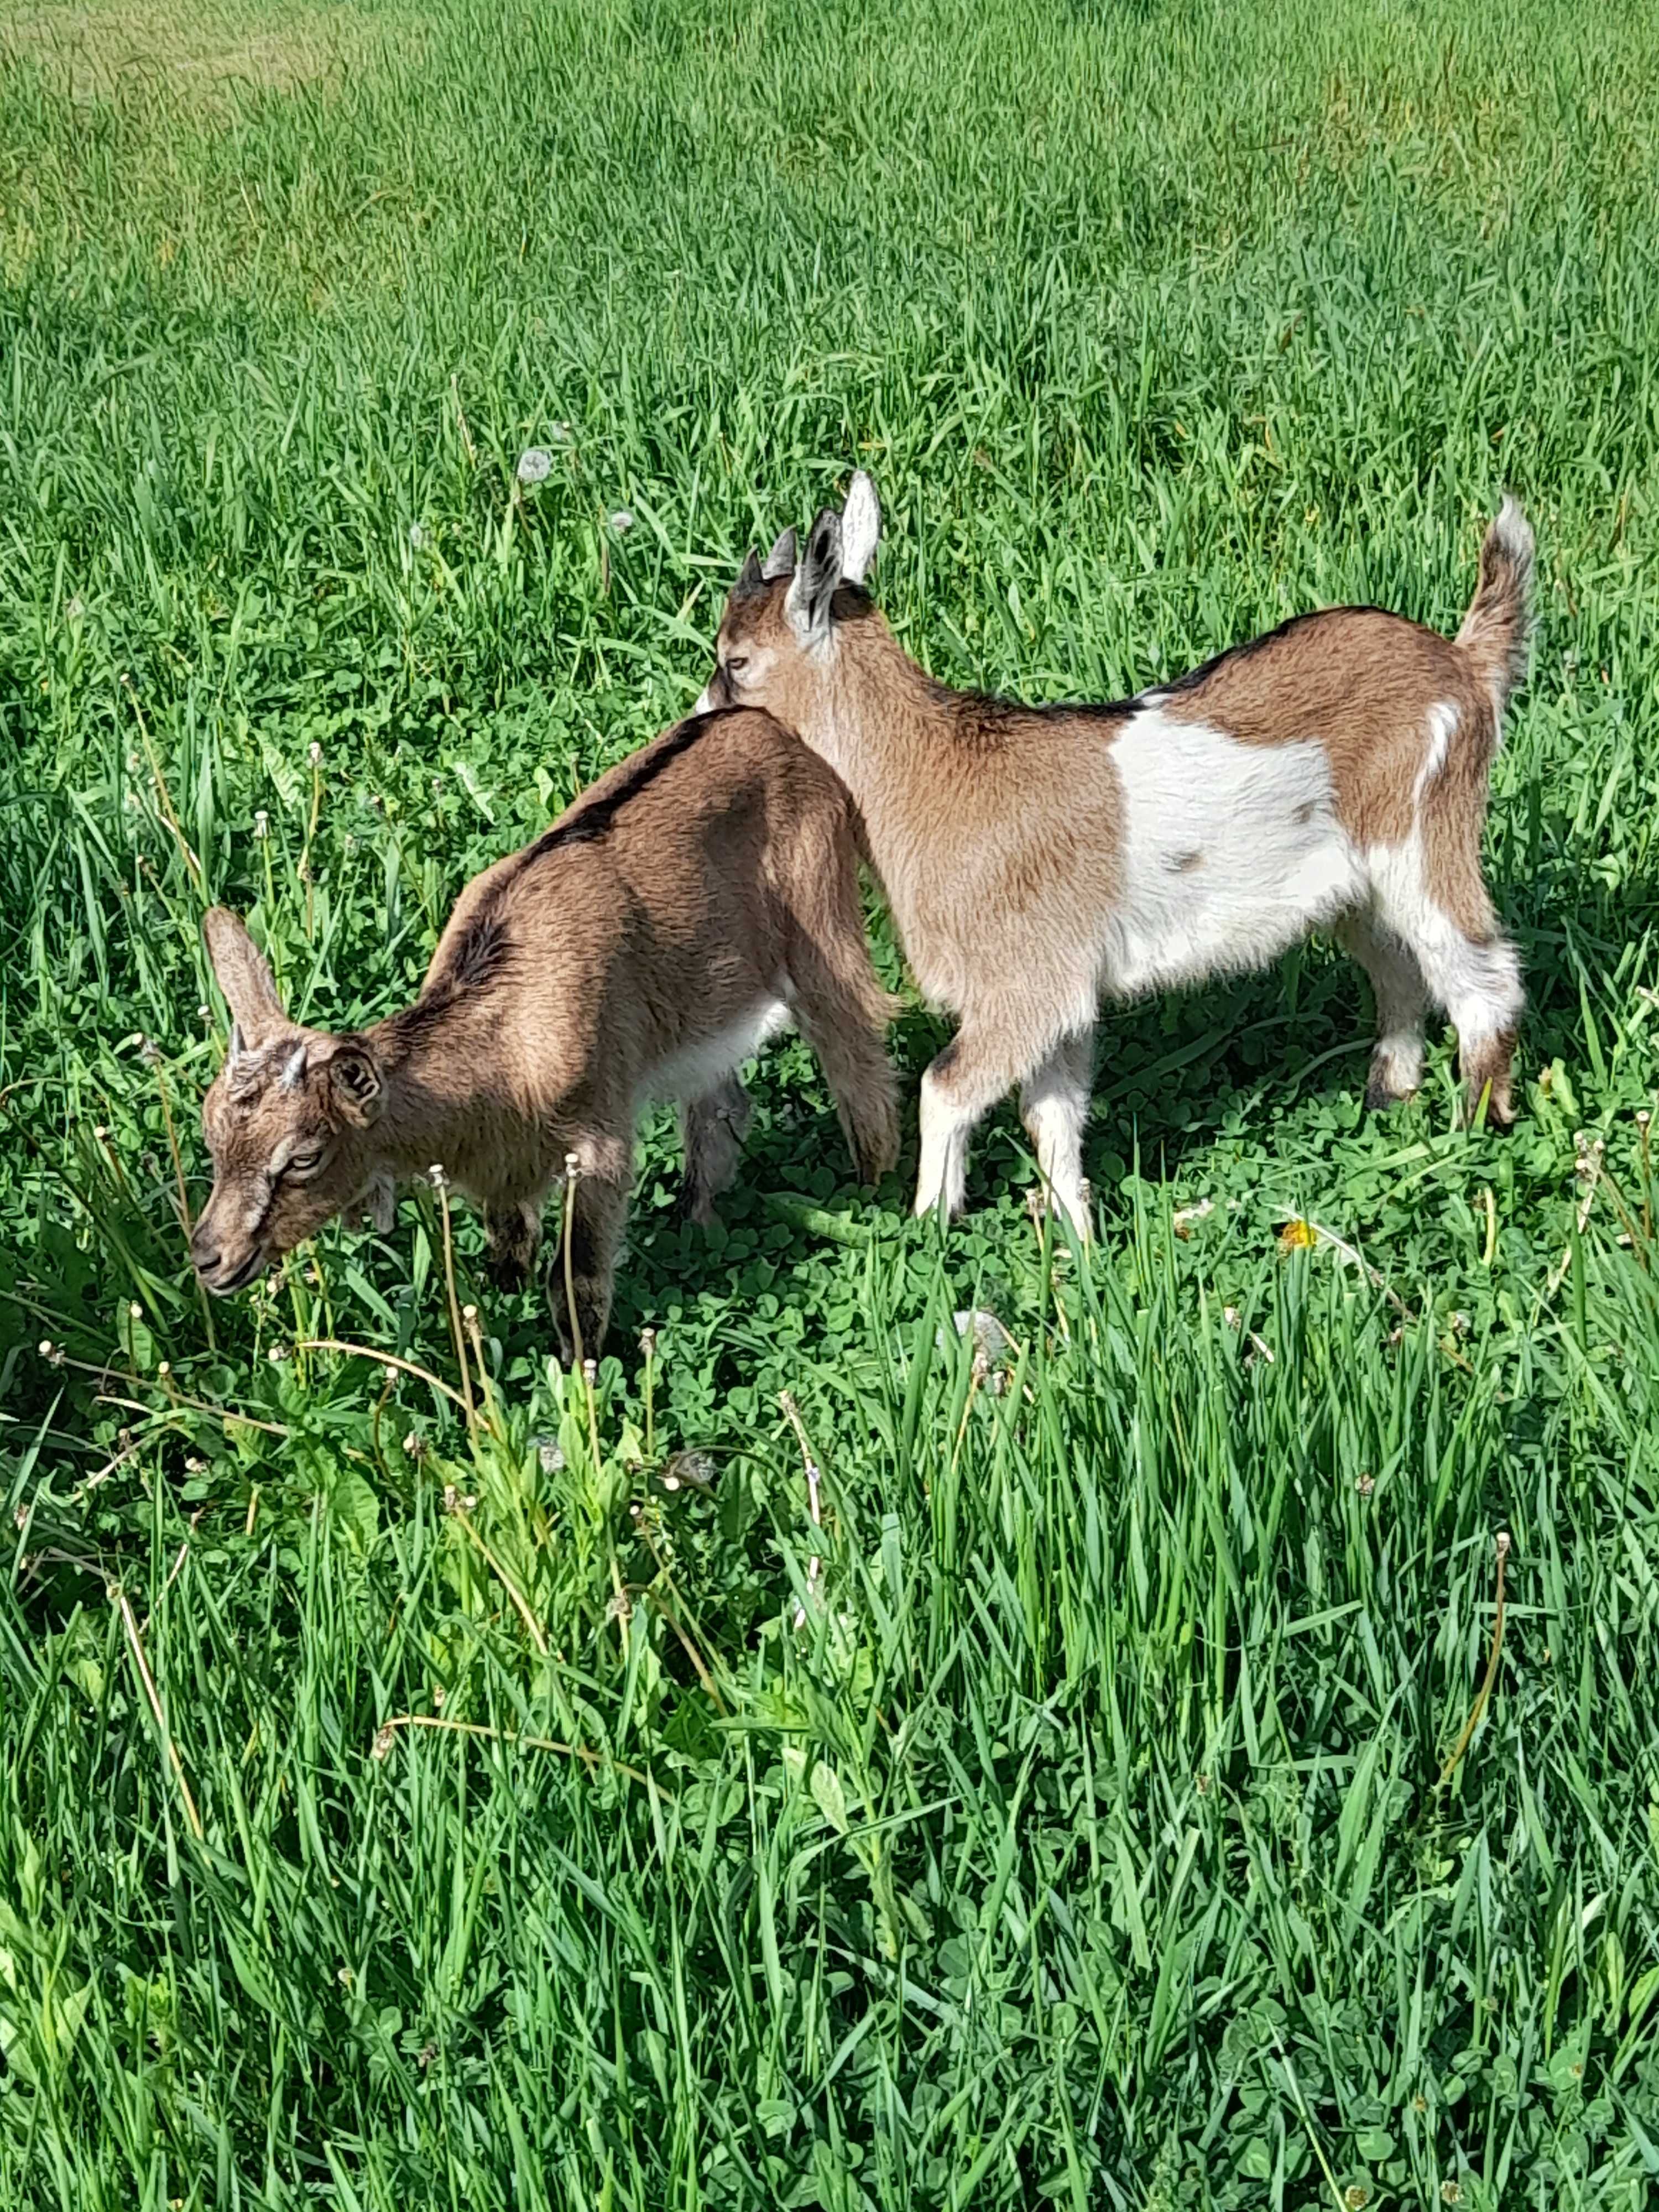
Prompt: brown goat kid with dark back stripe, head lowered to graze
<box><xmin>192</xmin><ymin>710</ymin><xmax>898</xmax><ymax>1354</ymax></box>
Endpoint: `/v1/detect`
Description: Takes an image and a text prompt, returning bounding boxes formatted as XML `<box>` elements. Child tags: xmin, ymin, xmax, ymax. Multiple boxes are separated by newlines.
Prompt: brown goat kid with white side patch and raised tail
<box><xmin>699</xmin><ymin>471</ymin><xmax>1533</xmax><ymax>1234</ymax></box>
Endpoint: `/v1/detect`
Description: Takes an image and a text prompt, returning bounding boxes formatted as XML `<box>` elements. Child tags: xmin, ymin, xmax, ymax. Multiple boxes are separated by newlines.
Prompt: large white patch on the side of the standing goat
<box><xmin>1102</xmin><ymin>703</ymin><xmax>1365</xmax><ymax>993</ymax></box>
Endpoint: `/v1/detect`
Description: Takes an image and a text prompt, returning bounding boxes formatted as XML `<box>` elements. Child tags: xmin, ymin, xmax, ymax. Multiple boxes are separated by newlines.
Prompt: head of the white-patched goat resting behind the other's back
<box><xmin>695</xmin><ymin>469</ymin><xmax>880</xmax><ymax>739</ymax></box>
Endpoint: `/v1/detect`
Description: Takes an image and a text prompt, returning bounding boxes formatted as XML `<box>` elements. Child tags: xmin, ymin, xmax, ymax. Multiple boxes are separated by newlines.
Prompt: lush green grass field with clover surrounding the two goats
<box><xmin>0</xmin><ymin>0</ymin><xmax>1659</xmax><ymax>2212</ymax></box>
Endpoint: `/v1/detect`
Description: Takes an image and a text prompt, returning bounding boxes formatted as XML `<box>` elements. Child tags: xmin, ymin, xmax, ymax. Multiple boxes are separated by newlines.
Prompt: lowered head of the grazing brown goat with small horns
<box><xmin>190</xmin><ymin>907</ymin><xmax>383</xmax><ymax>1296</ymax></box>
